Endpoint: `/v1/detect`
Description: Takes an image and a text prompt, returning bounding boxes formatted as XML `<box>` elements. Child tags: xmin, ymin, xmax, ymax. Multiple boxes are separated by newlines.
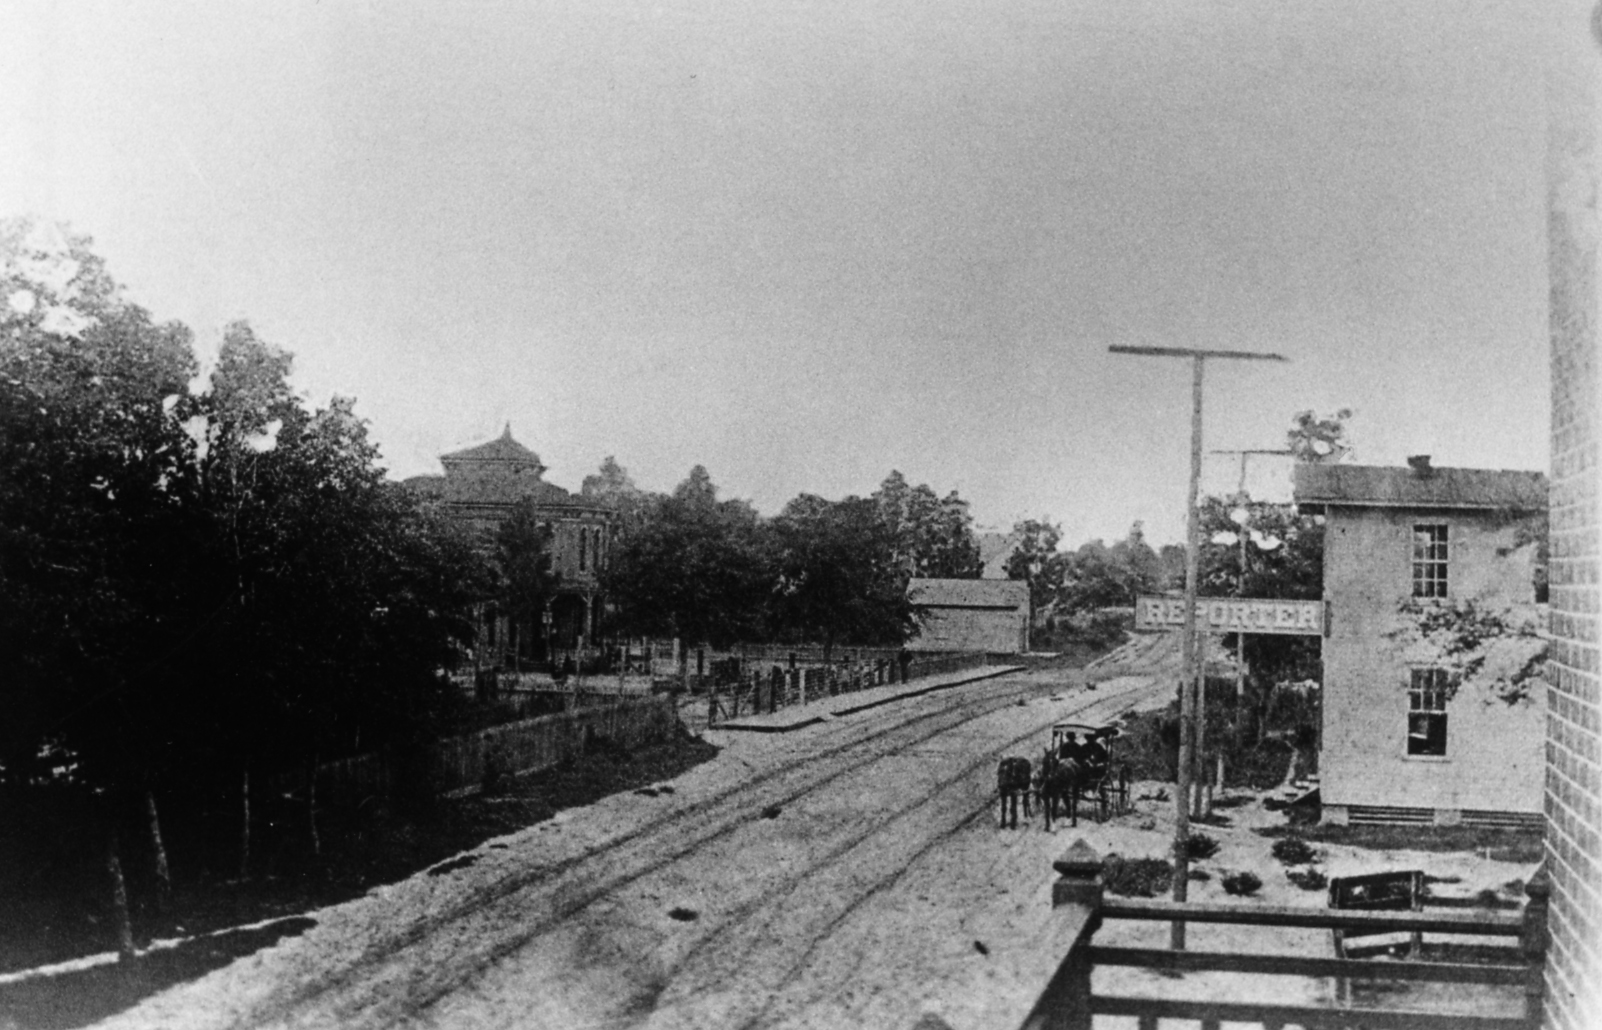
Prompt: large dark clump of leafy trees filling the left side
<box><xmin>0</xmin><ymin>223</ymin><xmax>487</xmax><ymax>877</ymax></box>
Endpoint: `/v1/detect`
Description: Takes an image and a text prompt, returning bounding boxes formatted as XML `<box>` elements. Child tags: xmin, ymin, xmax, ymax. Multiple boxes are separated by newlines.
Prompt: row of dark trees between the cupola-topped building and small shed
<box><xmin>585</xmin><ymin>470</ymin><xmax>961</xmax><ymax>646</ymax></box>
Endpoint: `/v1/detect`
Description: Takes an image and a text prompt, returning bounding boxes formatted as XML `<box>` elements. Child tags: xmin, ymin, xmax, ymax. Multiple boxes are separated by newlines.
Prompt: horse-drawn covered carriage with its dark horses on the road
<box><xmin>996</xmin><ymin>722</ymin><xmax>1129</xmax><ymax>830</ymax></box>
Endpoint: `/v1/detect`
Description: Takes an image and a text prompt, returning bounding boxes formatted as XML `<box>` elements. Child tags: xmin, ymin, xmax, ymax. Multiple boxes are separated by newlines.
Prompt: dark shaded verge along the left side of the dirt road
<box><xmin>0</xmin><ymin>734</ymin><xmax>718</xmax><ymax>1030</ymax></box>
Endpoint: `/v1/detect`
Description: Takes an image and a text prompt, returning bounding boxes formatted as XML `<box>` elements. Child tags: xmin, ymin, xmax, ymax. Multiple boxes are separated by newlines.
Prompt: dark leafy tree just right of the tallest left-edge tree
<box><xmin>175</xmin><ymin>324</ymin><xmax>490</xmax><ymax>791</ymax></box>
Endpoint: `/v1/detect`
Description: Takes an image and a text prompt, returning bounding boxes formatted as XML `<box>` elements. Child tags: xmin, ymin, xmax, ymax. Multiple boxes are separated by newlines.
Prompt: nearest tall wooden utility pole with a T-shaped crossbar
<box><xmin>1107</xmin><ymin>346</ymin><xmax>1285</xmax><ymax>952</ymax></box>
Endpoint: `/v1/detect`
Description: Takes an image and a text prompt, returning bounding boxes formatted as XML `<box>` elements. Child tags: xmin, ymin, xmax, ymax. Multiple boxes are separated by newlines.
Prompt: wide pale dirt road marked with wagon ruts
<box><xmin>104</xmin><ymin>671</ymin><xmax>1153</xmax><ymax>1028</ymax></box>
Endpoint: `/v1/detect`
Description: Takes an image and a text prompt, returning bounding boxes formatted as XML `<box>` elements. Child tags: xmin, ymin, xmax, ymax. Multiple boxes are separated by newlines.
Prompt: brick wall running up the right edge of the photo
<box><xmin>1544</xmin><ymin>0</ymin><xmax>1602</xmax><ymax>1030</ymax></box>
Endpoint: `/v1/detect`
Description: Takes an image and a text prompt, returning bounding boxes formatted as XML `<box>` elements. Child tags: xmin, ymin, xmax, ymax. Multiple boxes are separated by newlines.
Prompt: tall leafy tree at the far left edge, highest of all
<box><xmin>0</xmin><ymin>219</ymin><xmax>195</xmax><ymax>794</ymax></box>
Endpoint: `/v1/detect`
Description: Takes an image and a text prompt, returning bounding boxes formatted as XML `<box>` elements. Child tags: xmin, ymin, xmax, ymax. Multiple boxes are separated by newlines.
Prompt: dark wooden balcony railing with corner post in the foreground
<box><xmin>1024</xmin><ymin>841</ymin><xmax>1548</xmax><ymax>1030</ymax></box>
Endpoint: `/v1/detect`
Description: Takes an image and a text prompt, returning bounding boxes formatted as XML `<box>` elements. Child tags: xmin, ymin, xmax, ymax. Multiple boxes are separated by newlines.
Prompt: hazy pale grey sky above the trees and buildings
<box><xmin>0</xmin><ymin>0</ymin><xmax>1549</xmax><ymax>543</ymax></box>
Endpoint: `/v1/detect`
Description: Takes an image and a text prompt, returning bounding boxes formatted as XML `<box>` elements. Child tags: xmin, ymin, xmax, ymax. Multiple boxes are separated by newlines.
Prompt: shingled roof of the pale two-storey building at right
<box><xmin>1296</xmin><ymin>463</ymin><xmax>1546</xmax><ymax>511</ymax></box>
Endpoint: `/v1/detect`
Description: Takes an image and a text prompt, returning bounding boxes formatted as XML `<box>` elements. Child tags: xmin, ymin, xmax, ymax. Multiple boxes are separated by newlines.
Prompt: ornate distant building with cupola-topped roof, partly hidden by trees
<box><xmin>405</xmin><ymin>424</ymin><xmax>614</xmax><ymax>658</ymax></box>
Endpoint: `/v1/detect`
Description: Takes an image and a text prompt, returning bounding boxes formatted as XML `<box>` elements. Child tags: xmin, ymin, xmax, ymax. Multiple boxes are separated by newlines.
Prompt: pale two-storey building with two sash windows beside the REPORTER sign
<box><xmin>1296</xmin><ymin>458</ymin><xmax>1548</xmax><ymax>825</ymax></box>
